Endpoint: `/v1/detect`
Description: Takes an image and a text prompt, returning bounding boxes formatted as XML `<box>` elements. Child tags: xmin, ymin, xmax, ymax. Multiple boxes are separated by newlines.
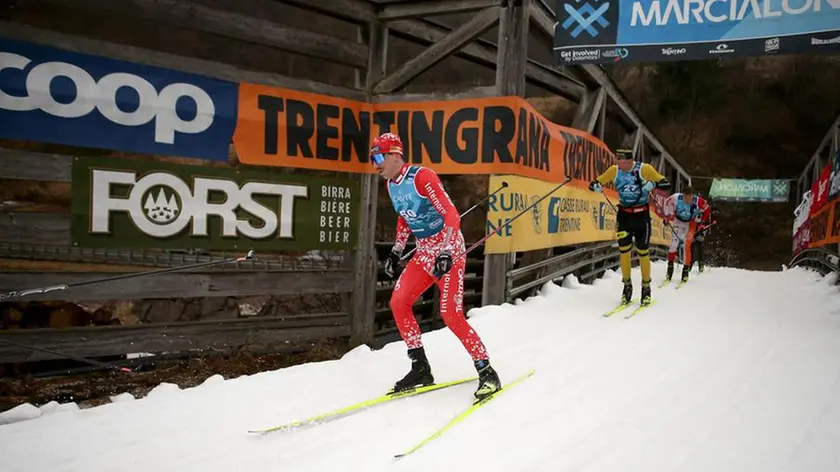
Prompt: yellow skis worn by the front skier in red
<box><xmin>248</xmin><ymin>369</ymin><xmax>534</xmax><ymax>459</ymax></box>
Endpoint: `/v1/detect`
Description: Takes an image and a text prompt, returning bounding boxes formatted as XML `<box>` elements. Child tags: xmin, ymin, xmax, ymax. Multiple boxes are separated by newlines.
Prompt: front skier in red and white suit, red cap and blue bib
<box><xmin>370</xmin><ymin>133</ymin><xmax>501</xmax><ymax>399</ymax></box>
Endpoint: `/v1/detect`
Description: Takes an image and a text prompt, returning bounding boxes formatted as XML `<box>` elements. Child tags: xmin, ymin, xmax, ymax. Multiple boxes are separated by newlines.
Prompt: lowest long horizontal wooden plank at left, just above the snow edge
<box><xmin>0</xmin><ymin>313</ymin><xmax>349</xmax><ymax>363</ymax></box>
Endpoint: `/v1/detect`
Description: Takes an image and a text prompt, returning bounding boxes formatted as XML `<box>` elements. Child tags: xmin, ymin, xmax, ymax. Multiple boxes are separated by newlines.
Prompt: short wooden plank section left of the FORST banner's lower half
<box><xmin>0</xmin><ymin>213</ymin><xmax>70</xmax><ymax>245</ymax></box>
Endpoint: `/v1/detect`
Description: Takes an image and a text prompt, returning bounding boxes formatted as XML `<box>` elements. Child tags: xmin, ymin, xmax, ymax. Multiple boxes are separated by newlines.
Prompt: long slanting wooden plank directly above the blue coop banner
<box><xmin>0</xmin><ymin>21</ymin><xmax>365</xmax><ymax>101</ymax></box>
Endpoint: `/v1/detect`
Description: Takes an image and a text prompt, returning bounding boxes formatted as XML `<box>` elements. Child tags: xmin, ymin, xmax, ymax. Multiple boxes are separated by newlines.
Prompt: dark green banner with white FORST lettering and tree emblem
<box><xmin>71</xmin><ymin>157</ymin><xmax>360</xmax><ymax>251</ymax></box>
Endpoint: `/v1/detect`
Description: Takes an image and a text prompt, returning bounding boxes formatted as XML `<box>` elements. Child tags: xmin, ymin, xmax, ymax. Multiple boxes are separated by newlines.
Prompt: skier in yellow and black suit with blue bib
<box><xmin>589</xmin><ymin>149</ymin><xmax>671</xmax><ymax>306</ymax></box>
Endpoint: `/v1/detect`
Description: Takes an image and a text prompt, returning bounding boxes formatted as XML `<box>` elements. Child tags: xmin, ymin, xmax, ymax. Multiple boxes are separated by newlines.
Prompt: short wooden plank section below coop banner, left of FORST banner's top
<box><xmin>0</xmin><ymin>148</ymin><xmax>73</xmax><ymax>182</ymax></box>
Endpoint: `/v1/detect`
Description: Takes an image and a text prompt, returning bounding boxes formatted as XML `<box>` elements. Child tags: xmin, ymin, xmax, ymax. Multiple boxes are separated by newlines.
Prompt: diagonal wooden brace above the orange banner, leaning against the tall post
<box><xmin>373</xmin><ymin>7</ymin><xmax>499</xmax><ymax>94</ymax></box>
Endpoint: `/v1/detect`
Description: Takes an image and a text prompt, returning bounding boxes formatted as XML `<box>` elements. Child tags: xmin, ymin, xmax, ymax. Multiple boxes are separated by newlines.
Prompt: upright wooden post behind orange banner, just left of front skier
<box><xmin>350</xmin><ymin>22</ymin><xmax>388</xmax><ymax>346</ymax></box>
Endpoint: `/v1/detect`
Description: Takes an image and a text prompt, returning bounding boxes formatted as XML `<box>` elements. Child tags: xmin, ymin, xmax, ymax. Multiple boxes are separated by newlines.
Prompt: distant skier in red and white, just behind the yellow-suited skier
<box><xmin>663</xmin><ymin>185</ymin><xmax>711</xmax><ymax>282</ymax></box>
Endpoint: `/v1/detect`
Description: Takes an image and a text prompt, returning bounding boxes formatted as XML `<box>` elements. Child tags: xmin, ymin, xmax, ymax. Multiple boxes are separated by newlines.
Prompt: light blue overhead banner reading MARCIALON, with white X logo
<box><xmin>554</xmin><ymin>0</ymin><xmax>840</xmax><ymax>65</ymax></box>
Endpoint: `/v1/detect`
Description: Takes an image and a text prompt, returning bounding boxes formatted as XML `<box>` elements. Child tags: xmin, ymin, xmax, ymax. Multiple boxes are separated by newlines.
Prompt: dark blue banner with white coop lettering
<box><xmin>0</xmin><ymin>39</ymin><xmax>239</xmax><ymax>161</ymax></box>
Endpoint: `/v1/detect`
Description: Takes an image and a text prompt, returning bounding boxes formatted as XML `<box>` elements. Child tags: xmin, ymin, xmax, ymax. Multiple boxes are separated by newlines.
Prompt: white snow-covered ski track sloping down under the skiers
<box><xmin>0</xmin><ymin>263</ymin><xmax>840</xmax><ymax>472</ymax></box>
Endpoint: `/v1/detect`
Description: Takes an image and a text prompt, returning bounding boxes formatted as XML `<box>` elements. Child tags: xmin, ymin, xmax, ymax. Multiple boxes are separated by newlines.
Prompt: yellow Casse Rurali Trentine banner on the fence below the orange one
<box><xmin>484</xmin><ymin>175</ymin><xmax>671</xmax><ymax>254</ymax></box>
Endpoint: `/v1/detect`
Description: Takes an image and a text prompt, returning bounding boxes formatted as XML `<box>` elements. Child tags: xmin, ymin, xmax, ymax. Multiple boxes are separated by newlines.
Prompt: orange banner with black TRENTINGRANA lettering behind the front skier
<box><xmin>234</xmin><ymin>83</ymin><xmax>613</xmax><ymax>182</ymax></box>
